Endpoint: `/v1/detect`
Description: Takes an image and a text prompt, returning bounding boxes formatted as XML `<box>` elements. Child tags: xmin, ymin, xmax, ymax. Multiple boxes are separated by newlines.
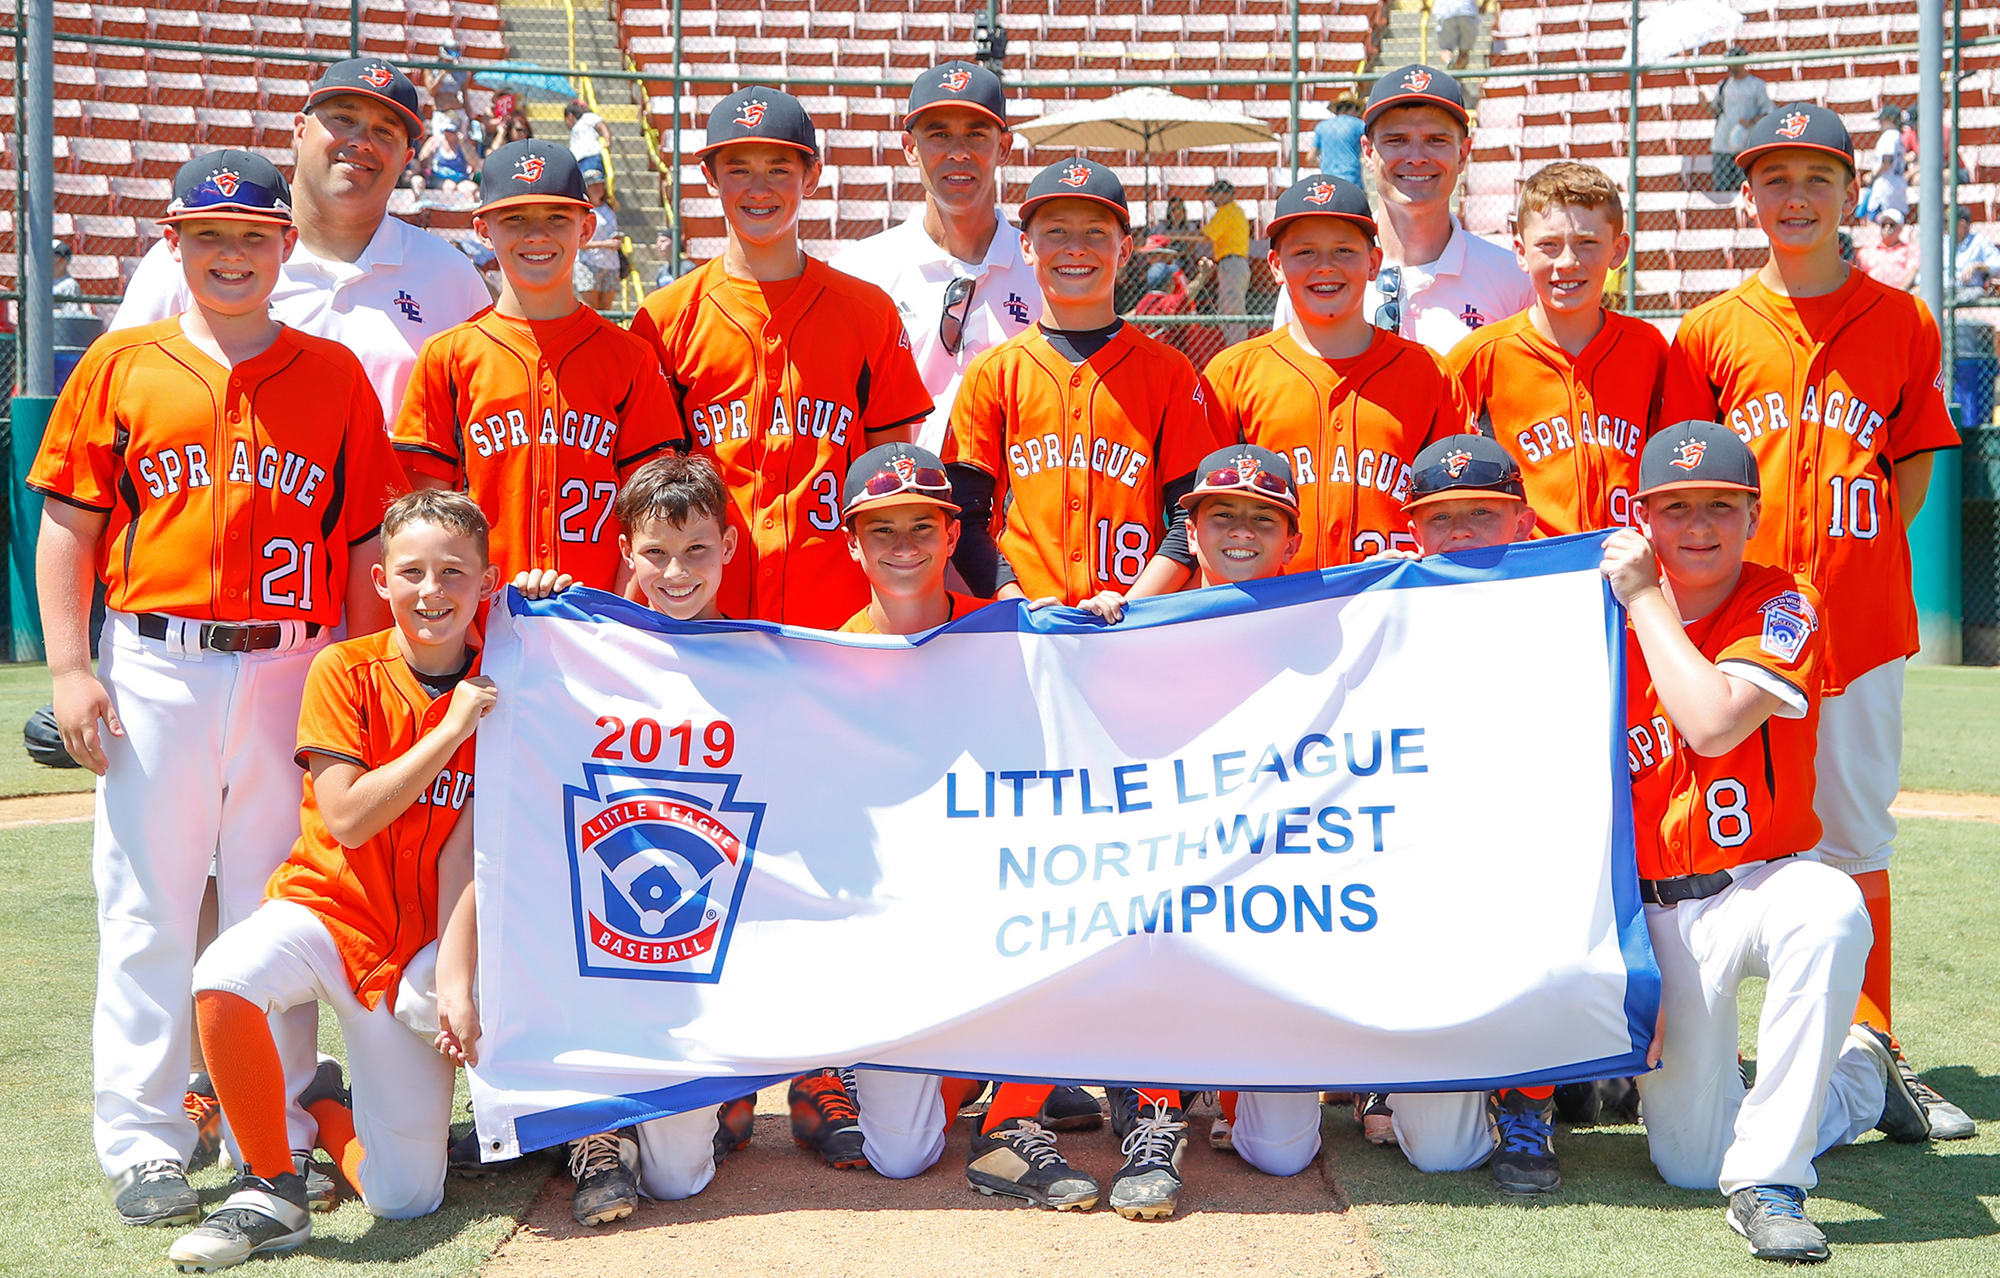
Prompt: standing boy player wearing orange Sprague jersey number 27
<box><xmin>394</xmin><ymin>138</ymin><xmax>686</xmax><ymax>590</ymax></box>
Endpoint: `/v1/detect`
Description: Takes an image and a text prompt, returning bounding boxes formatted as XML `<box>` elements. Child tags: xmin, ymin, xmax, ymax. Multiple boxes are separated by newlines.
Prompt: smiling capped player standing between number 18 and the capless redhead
<box><xmin>1204</xmin><ymin>174</ymin><xmax>1466</xmax><ymax>570</ymax></box>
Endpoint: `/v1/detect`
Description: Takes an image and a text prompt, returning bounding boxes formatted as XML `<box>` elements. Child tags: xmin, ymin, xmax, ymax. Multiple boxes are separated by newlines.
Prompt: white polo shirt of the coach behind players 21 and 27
<box><xmin>112</xmin><ymin>216</ymin><xmax>492</xmax><ymax>424</ymax></box>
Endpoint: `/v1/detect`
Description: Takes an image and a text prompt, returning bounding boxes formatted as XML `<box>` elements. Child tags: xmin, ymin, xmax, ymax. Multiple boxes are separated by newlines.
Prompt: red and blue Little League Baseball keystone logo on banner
<box><xmin>562</xmin><ymin>764</ymin><xmax>764</xmax><ymax>984</ymax></box>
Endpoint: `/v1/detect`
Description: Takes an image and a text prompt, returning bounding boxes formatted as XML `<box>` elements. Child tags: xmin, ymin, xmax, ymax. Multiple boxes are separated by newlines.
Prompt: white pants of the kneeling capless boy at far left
<box><xmin>194</xmin><ymin>900</ymin><xmax>458</xmax><ymax>1220</ymax></box>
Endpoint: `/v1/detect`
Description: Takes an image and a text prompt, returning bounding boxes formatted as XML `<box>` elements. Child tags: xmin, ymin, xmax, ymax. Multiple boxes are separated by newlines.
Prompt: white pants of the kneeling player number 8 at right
<box><xmin>1638</xmin><ymin>856</ymin><xmax>1884</xmax><ymax>1194</ymax></box>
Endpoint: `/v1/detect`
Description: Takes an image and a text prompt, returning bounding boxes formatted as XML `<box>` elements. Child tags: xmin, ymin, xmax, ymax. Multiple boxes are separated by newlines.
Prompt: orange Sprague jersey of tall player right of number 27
<box><xmin>632</xmin><ymin>258</ymin><xmax>930</xmax><ymax>630</ymax></box>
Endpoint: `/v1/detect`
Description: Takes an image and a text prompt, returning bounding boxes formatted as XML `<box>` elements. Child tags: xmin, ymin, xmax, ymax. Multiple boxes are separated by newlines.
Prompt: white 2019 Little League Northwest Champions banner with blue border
<box><xmin>472</xmin><ymin>534</ymin><xmax>1658</xmax><ymax>1154</ymax></box>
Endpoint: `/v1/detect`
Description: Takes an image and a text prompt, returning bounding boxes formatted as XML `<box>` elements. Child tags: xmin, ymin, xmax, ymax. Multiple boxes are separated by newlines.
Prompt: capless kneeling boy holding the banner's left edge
<box><xmin>166</xmin><ymin>492</ymin><xmax>500</xmax><ymax>1274</ymax></box>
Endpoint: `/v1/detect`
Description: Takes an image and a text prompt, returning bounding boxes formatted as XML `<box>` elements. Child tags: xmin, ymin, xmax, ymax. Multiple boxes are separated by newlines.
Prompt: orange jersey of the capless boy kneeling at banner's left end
<box><xmin>264</xmin><ymin>630</ymin><xmax>476</xmax><ymax>1010</ymax></box>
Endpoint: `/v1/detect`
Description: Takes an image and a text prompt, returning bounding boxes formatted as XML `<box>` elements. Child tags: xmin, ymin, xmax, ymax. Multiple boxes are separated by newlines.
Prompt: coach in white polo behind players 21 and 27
<box><xmin>112</xmin><ymin>58</ymin><xmax>492</xmax><ymax>422</ymax></box>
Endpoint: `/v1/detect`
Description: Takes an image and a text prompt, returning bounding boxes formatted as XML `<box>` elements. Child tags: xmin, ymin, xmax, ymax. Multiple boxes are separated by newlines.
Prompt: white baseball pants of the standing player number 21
<box><xmin>90</xmin><ymin>612</ymin><xmax>324</xmax><ymax>1176</ymax></box>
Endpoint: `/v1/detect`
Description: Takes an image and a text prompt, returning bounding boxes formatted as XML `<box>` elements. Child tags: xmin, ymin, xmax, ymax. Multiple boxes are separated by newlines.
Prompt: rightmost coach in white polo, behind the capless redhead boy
<box><xmin>1274</xmin><ymin>66</ymin><xmax>1534</xmax><ymax>354</ymax></box>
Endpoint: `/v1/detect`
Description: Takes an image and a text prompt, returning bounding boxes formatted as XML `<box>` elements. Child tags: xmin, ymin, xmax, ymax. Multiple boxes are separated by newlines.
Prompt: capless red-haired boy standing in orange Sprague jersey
<box><xmin>1446</xmin><ymin>160</ymin><xmax>1666</xmax><ymax>536</ymax></box>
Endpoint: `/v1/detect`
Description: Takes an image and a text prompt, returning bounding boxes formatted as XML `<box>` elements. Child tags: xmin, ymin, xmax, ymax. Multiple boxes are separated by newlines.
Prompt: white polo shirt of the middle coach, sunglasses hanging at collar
<box><xmin>828</xmin><ymin>206</ymin><xmax>1042</xmax><ymax>452</ymax></box>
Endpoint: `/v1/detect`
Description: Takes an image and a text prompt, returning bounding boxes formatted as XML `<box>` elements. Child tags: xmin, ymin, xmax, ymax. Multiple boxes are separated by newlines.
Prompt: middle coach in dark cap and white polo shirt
<box><xmin>830</xmin><ymin>62</ymin><xmax>1042</xmax><ymax>452</ymax></box>
